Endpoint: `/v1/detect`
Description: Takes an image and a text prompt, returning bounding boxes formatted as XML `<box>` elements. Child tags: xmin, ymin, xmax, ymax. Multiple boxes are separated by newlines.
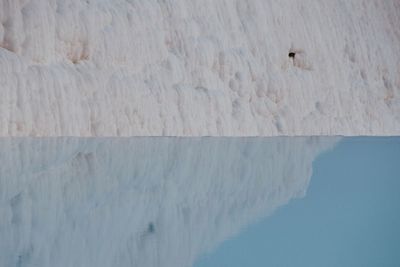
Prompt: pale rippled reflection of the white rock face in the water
<box><xmin>0</xmin><ymin>137</ymin><xmax>337</xmax><ymax>267</ymax></box>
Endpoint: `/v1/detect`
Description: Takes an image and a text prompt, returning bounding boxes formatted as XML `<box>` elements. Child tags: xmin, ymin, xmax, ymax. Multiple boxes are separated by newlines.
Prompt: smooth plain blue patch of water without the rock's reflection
<box><xmin>195</xmin><ymin>137</ymin><xmax>400</xmax><ymax>267</ymax></box>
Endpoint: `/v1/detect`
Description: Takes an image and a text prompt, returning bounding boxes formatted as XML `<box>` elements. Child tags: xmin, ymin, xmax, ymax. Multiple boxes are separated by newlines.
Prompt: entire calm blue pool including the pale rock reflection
<box><xmin>0</xmin><ymin>137</ymin><xmax>400</xmax><ymax>267</ymax></box>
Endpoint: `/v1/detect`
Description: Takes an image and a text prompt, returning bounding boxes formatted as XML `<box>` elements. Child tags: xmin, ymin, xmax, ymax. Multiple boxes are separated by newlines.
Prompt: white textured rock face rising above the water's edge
<box><xmin>0</xmin><ymin>0</ymin><xmax>400</xmax><ymax>136</ymax></box>
